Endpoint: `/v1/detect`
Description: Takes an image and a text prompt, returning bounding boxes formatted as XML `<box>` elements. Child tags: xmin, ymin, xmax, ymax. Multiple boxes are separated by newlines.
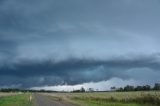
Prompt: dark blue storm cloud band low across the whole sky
<box><xmin>0</xmin><ymin>55</ymin><xmax>160</xmax><ymax>87</ymax></box>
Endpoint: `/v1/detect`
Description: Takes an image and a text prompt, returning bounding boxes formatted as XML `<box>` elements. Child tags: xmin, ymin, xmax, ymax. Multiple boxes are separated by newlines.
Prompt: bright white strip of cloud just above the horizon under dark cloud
<box><xmin>31</xmin><ymin>78</ymin><xmax>141</xmax><ymax>91</ymax></box>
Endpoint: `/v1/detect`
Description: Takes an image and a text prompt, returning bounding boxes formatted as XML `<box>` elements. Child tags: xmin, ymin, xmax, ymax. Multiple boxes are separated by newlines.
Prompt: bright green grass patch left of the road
<box><xmin>0</xmin><ymin>93</ymin><xmax>32</xmax><ymax>106</ymax></box>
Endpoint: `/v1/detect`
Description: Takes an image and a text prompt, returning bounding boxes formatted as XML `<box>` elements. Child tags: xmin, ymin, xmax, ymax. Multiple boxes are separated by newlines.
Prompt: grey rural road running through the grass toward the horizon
<box><xmin>34</xmin><ymin>94</ymin><xmax>73</xmax><ymax>106</ymax></box>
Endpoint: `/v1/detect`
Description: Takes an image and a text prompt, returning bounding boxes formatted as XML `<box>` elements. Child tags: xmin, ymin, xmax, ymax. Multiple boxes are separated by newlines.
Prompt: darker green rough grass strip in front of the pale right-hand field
<box><xmin>71</xmin><ymin>97</ymin><xmax>159</xmax><ymax>106</ymax></box>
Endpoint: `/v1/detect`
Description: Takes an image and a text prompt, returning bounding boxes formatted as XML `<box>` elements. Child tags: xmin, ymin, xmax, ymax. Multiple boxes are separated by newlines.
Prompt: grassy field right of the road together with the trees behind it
<box><xmin>42</xmin><ymin>83</ymin><xmax>160</xmax><ymax>106</ymax></box>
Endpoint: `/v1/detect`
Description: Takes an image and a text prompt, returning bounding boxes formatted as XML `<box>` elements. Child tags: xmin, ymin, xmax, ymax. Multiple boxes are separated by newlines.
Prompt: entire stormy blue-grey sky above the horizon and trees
<box><xmin>0</xmin><ymin>0</ymin><xmax>160</xmax><ymax>90</ymax></box>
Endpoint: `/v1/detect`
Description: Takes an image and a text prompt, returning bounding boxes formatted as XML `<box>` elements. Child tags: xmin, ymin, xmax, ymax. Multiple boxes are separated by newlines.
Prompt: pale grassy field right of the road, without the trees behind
<box><xmin>45</xmin><ymin>91</ymin><xmax>160</xmax><ymax>106</ymax></box>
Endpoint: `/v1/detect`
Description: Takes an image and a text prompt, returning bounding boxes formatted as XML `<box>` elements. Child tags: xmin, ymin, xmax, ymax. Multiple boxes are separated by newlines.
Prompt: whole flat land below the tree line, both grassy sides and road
<box><xmin>0</xmin><ymin>91</ymin><xmax>160</xmax><ymax>106</ymax></box>
